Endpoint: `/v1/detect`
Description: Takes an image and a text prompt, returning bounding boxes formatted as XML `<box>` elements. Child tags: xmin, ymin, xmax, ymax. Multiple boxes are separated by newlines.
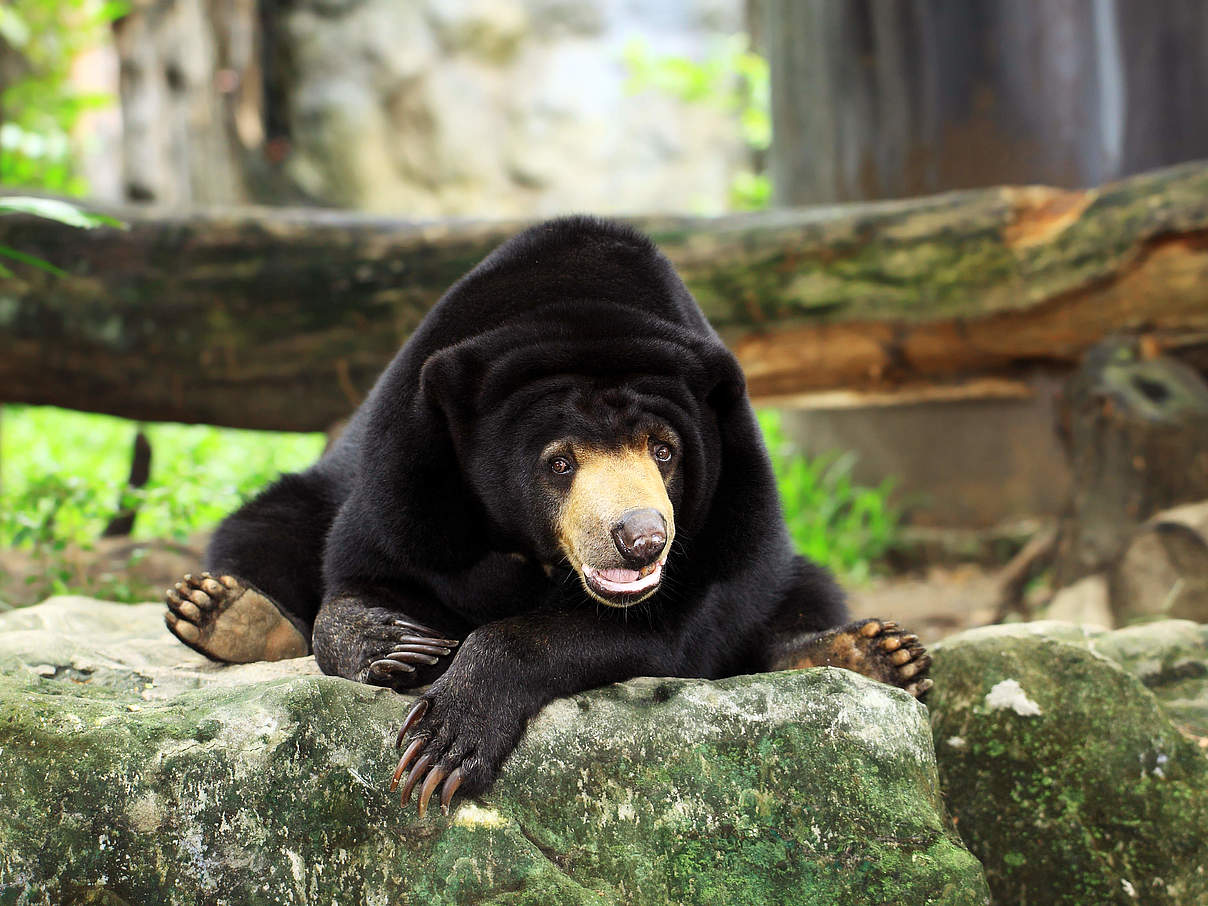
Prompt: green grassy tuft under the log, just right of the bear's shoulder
<box><xmin>759</xmin><ymin>411</ymin><xmax>901</xmax><ymax>581</ymax></box>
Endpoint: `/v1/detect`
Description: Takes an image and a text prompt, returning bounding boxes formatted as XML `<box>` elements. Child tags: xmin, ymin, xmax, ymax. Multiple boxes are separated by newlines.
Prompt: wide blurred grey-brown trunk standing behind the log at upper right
<box><xmin>765</xmin><ymin>0</ymin><xmax>1208</xmax><ymax>205</ymax></box>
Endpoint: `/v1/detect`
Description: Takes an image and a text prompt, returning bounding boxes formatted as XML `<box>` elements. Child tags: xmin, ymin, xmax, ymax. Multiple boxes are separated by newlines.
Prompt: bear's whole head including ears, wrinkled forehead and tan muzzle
<box><xmin>422</xmin><ymin>311</ymin><xmax>742</xmax><ymax>608</ymax></box>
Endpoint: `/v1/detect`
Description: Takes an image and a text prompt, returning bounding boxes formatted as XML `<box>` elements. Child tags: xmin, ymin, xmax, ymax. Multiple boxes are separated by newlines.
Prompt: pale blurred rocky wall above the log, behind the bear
<box><xmin>279</xmin><ymin>0</ymin><xmax>745</xmax><ymax>216</ymax></box>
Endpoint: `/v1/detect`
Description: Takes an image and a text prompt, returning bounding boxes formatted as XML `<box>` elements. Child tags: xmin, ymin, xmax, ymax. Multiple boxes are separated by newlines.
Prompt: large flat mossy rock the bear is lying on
<box><xmin>0</xmin><ymin>598</ymin><xmax>987</xmax><ymax>906</ymax></box>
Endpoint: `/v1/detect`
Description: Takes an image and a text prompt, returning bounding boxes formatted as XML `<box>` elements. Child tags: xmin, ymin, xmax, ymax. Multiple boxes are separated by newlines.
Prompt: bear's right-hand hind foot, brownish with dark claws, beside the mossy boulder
<box><xmin>772</xmin><ymin>620</ymin><xmax>931</xmax><ymax>698</ymax></box>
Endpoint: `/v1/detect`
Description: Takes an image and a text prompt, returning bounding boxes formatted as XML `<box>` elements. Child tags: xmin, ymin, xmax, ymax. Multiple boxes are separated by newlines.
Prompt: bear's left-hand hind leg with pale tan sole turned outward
<box><xmin>164</xmin><ymin>472</ymin><xmax>336</xmax><ymax>663</ymax></box>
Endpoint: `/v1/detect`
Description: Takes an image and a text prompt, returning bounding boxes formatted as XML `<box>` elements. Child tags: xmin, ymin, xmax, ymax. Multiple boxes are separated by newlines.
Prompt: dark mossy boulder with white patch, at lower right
<box><xmin>928</xmin><ymin>621</ymin><xmax>1208</xmax><ymax>906</ymax></box>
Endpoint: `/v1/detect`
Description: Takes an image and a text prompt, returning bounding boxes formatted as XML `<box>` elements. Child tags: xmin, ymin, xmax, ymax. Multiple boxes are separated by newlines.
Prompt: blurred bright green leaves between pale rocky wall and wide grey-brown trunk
<box><xmin>622</xmin><ymin>34</ymin><xmax>772</xmax><ymax>210</ymax></box>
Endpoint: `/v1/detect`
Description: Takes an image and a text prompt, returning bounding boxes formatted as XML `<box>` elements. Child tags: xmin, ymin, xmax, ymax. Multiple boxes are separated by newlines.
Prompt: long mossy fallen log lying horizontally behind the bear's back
<box><xmin>7</xmin><ymin>163</ymin><xmax>1208</xmax><ymax>430</ymax></box>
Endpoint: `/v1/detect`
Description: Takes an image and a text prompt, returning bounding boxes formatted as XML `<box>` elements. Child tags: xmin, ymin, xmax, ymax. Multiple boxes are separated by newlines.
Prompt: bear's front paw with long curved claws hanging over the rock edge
<box><xmin>390</xmin><ymin>680</ymin><xmax>524</xmax><ymax>818</ymax></box>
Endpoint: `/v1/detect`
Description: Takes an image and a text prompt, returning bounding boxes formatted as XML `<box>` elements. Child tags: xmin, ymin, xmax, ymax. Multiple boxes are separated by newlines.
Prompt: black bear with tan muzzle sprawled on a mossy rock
<box><xmin>165</xmin><ymin>216</ymin><xmax>931</xmax><ymax>815</ymax></box>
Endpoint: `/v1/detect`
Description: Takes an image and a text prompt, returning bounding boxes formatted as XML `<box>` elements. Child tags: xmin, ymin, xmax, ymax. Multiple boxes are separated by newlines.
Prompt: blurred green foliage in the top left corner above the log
<box><xmin>0</xmin><ymin>0</ymin><xmax>129</xmax><ymax>194</ymax></box>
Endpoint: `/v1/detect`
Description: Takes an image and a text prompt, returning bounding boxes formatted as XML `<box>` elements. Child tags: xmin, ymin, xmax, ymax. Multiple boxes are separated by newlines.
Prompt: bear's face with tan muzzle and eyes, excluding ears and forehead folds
<box><xmin>488</xmin><ymin>378</ymin><xmax>684</xmax><ymax>606</ymax></box>
